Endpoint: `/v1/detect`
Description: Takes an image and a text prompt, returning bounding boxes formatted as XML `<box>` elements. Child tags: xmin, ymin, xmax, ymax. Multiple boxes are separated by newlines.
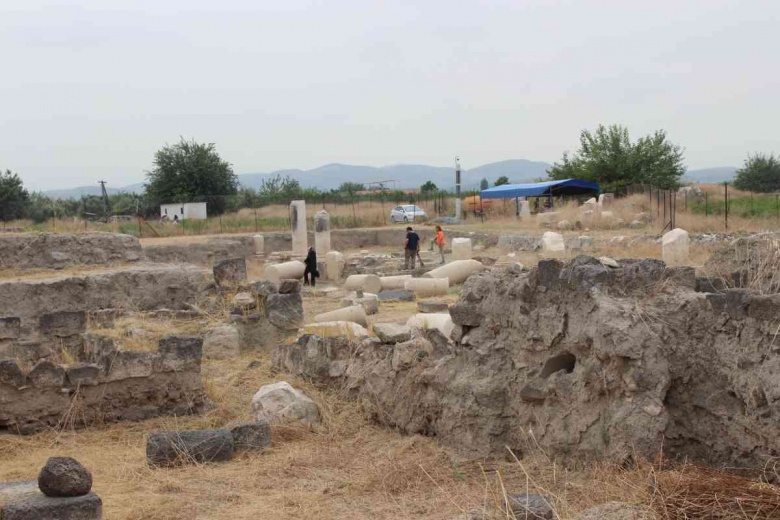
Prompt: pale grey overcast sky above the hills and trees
<box><xmin>0</xmin><ymin>0</ymin><xmax>780</xmax><ymax>189</ymax></box>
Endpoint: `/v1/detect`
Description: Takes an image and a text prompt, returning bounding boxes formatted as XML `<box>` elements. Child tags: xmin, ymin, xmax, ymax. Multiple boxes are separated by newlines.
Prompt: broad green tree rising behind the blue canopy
<box><xmin>547</xmin><ymin>125</ymin><xmax>685</xmax><ymax>191</ymax></box>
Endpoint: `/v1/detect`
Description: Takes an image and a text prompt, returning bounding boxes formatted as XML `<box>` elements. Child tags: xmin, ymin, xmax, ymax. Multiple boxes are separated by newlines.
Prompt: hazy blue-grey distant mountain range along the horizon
<box><xmin>43</xmin><ymin>159</ymin><xmax>737</xmax><ymax>199</ymax></box>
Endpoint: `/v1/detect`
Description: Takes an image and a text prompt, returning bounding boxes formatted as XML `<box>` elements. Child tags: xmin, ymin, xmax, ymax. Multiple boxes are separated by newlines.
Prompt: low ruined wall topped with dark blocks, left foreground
<box><xmin>0</xmin><ymin>334</ymin><xmax>206</xmax><ymax>434</ymax></box>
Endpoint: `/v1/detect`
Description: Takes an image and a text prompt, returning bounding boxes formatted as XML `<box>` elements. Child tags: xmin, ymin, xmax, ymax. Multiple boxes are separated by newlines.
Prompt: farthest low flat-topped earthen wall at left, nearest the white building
<box><xmin>0</xmin><ymin>233</ymin><xmax>144</xmax><ymax>269</ymax></box>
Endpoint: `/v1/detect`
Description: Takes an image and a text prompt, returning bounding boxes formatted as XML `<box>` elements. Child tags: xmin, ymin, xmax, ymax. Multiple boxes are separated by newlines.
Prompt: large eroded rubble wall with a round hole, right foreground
<box><xmin>274</xmin><ymin>257</ymin><xmax>780</xmax><ymax>467</ymax></box>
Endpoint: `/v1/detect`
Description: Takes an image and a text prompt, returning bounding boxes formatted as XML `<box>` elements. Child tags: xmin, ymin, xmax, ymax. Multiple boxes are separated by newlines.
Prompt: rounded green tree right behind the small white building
<box><xmin>146</xmin><ymin>138</ymin><xmax>238</xmax><ymax>214</ymax></box>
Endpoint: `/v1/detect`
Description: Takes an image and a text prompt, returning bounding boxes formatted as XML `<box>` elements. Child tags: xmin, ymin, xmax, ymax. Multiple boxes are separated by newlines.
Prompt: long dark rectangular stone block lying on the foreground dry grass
<box><xmin>146</xmin><ymin>429</ymin><xmax>233</xmax><ymax>466</ymax></box>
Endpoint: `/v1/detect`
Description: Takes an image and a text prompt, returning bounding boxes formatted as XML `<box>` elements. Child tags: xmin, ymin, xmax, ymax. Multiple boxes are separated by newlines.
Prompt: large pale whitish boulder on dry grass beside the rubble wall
<box><xmin>252</xmin><ymin>381</ymin><xmax>321</xmax><ymax>427</ymax></box>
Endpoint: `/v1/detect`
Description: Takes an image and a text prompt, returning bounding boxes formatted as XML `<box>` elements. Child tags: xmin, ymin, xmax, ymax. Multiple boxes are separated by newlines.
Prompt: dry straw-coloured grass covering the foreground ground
<box><xmin>0</xmin><ymin>350</ymin><xmax>660</xmax><ymax>520</ymax></box>
